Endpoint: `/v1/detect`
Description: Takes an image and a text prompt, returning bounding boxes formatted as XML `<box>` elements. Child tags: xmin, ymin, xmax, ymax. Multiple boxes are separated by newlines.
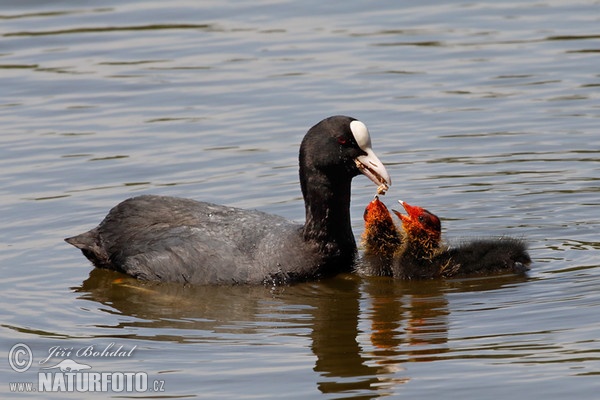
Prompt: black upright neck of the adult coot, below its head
<box><xmin>300</xmin><ymin>167</ymin><xmax>356</xmax><ymax>260</ymax></box>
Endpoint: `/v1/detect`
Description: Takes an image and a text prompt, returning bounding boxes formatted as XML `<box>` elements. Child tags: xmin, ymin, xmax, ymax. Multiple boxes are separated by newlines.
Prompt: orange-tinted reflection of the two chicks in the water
<box><xmin>363</xmin><ymin>275</ymin><xmax>528</xmax><ymax>395</ymax></box>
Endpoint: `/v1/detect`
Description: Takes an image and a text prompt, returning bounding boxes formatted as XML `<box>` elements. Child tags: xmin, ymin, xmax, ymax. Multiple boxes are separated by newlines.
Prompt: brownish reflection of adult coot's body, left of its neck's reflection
<box><xmin>74</xmin><ymin>268</ymin><xmax>292</xmax><ymax>341</ymax></box>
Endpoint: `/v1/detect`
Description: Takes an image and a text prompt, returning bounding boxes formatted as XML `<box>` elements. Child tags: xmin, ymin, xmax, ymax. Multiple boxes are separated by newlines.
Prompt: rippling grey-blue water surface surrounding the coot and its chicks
<box><xmin>0</xmin><ymin>0</ymin><xmax>600</xmax><ymax>399</ymax></box>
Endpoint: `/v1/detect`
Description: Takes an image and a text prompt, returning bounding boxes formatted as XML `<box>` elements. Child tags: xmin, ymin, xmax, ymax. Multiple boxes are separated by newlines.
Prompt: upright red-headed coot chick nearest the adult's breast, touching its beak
<box><xmin>359</xmin><ymin>196</ymin><xmax>402</xmax><ymax>276</ymax></box>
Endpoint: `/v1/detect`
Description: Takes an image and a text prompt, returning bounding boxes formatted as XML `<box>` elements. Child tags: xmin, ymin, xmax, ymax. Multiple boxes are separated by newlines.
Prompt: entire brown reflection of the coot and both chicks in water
<box><xmin>74</xmin><ymin>269</ymin><xmax>526</xmax><ymax>398</ymax></box>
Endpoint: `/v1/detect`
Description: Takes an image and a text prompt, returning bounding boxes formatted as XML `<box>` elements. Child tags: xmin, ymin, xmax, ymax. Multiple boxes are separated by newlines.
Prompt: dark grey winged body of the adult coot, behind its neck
<box><xmin>68</xmin><ymin>196</ymin><xmax>299</xmax><ymax>284</ymax></box>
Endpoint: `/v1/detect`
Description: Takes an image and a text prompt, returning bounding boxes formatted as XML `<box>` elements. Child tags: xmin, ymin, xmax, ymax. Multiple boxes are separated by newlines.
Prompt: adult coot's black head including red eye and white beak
<box><xmin>300</xmin><ymin>115</ymin><xmax>391</xmax><ymax>192</ymax></box>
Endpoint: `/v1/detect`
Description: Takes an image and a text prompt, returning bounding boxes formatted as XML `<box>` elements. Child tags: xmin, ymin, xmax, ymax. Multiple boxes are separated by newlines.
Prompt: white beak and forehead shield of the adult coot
<box><xmin>350</xmin><ymin>121</ymin><xmax>392</xmax><ymax>194</ymax></box>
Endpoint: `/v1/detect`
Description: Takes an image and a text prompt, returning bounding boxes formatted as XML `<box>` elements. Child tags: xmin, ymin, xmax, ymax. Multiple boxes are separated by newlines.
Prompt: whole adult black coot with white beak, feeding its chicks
<box><xmin>65</xmin><ymin>116</ymin><xmax>391</xmax><ymax>284</ymax></box>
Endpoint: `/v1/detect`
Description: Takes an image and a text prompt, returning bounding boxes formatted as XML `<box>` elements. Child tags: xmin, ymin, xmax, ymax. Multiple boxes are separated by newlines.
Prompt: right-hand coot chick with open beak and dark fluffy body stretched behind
<box><xmin>392</xmin><ymin>201</ymin><xmax>531</xmax><ymax>279</ymax></box>
